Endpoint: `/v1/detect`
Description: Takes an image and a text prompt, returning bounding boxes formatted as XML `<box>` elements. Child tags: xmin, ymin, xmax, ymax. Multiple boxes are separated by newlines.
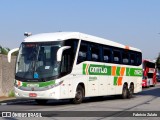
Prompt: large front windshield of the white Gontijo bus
<box><xmin>16</xmin><ymin>42</ymin><xmax>63</xmax><ymax>80</ymax></box>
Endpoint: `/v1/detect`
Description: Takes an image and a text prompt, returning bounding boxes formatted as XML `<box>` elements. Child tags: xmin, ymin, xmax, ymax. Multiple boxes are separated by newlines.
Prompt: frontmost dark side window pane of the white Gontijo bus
<box><xmin>77</xmin><ymin>44</ymin><xmax>87</xmax><ymax>64</ymax></box>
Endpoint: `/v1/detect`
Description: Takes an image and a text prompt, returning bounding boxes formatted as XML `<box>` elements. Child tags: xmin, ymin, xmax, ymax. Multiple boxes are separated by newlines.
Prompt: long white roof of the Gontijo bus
<box><xmin>24</xmin><ymin>32</ymin><xmax>141</xmax><ymax>52</ymax></box>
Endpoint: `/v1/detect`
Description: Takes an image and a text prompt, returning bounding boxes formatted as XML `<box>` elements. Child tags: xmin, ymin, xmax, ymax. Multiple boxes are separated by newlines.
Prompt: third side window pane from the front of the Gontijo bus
<box><xmin>103</xmin><ymin>48</ymin><xmax>111</xmax><ymax>63</ymax></box>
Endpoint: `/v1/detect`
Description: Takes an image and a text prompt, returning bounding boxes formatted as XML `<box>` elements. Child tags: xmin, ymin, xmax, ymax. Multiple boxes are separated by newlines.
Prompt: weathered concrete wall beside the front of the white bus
<box><xmin>0</xmin><ymin>54</ymin><xmax>16</xmax><ymax>96</ymax></box>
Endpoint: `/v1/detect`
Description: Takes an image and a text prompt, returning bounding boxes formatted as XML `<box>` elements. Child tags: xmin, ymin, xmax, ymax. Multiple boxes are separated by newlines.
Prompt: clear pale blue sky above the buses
<box><xmin>0</xmin><ymin>0</ymin><xmax>160</xmax><ymax>60</ymax></box>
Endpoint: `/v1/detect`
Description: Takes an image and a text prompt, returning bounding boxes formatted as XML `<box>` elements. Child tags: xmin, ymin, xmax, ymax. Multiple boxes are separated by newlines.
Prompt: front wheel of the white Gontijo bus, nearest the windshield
<box><xmin>72</xmin><ymin>85</ymin><xmax>84</xmax><ymax>104</ymax></box>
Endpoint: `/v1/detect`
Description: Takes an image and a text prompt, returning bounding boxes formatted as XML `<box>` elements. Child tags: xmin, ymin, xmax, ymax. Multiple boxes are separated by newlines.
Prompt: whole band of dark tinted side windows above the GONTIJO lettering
<box><xmin>77</xmin><ymin>40</ymin><xmax>142</xmax><ymax>66</ymax></box>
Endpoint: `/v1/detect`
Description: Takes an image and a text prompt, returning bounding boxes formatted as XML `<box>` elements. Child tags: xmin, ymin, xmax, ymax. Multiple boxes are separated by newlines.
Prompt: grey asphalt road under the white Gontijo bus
<box><xmin>0</xmin><ymin>84</ymin><xmax>160</xmax><ymax>120</ymax></box>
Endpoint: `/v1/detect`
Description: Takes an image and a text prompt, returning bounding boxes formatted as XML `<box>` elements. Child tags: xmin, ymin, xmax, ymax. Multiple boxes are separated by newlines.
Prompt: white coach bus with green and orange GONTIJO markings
<box><xmin>8</xmin><ymin>32</ymin><xmax>142</xmax><ymax>104</ymax></box>
